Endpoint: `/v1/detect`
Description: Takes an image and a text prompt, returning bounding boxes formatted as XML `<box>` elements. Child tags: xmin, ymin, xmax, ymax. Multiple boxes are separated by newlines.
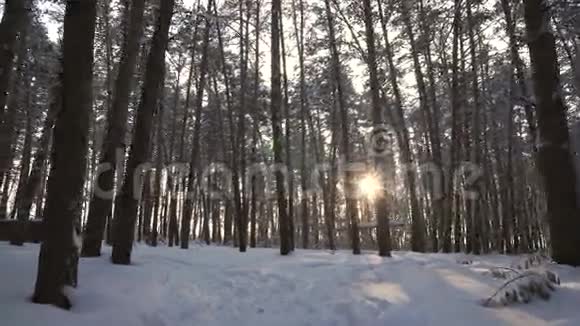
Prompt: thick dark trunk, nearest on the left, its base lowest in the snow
<box><xmin>33</xmin><ymin>0</ymin><xmax>97</xmax><ymax>309</ymax></box>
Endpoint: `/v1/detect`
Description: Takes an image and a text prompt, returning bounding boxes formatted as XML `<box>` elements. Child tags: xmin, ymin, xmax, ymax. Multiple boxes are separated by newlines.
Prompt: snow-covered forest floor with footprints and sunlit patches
<box><xmin>0</xmin><ymin>243</ymin><xmax>580</xmax><ymax>326</ymax></box>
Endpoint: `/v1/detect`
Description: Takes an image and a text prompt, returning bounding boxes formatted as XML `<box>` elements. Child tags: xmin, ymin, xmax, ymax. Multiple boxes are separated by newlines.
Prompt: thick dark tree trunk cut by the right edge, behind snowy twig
<box><xmin>524</xmin><ymin>0</ymin><xmax>580</xmax><ymax>266</ymax></box>
